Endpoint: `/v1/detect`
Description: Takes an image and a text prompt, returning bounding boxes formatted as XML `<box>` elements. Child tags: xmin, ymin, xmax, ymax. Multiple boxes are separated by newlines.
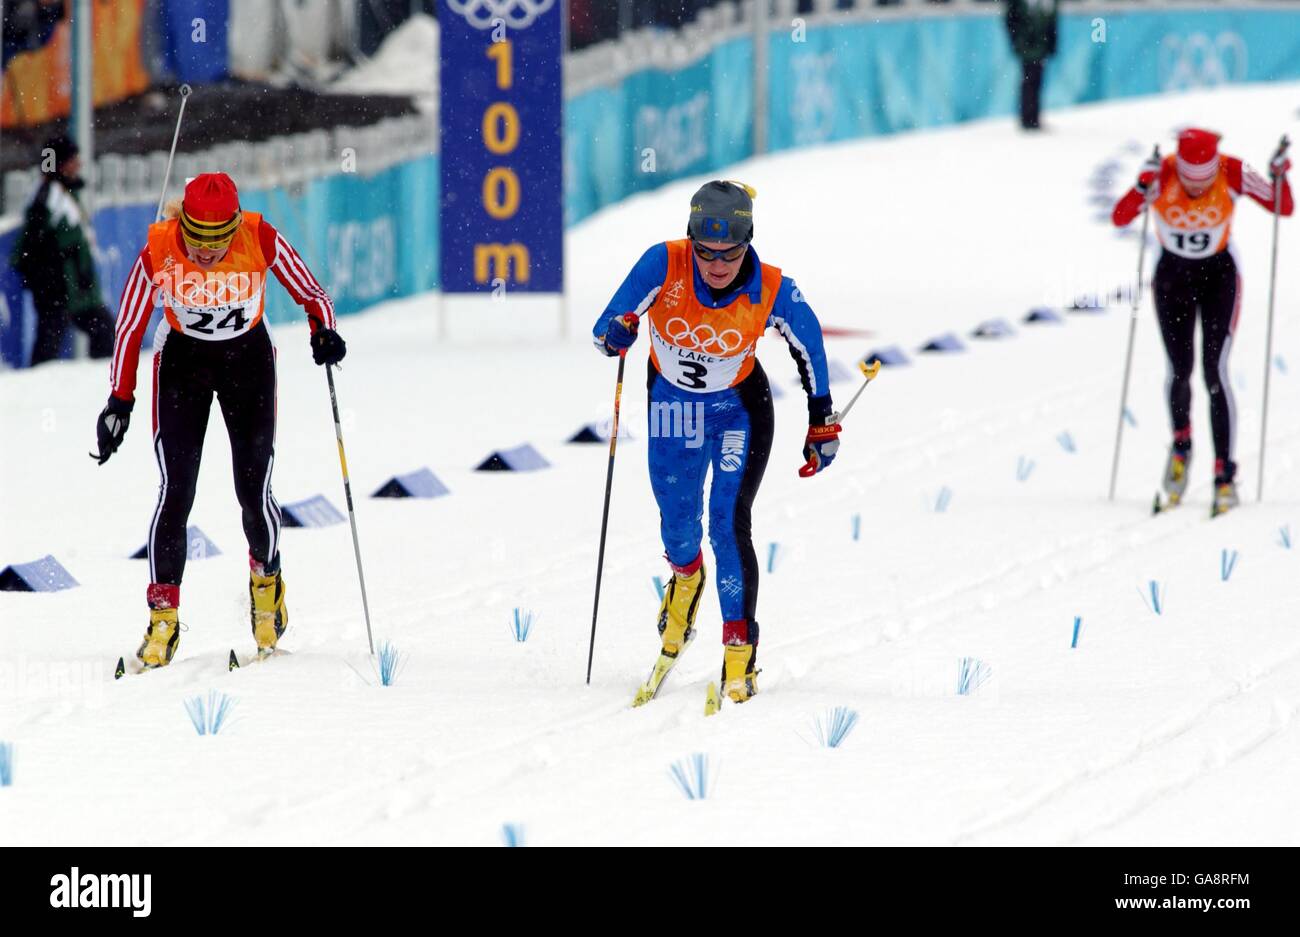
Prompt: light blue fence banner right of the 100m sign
<box><xmin>566</xmin><ymin>4</ymin><xmax>1300</xmax><ymax>224</ymax></box>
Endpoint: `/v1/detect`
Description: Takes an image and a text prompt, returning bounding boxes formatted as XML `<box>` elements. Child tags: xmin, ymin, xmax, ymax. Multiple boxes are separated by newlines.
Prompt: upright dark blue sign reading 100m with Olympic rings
<box><xmin>438</xmin><ymin>0</ymin><xmax>564</xmax><ymax>295</ymax></box>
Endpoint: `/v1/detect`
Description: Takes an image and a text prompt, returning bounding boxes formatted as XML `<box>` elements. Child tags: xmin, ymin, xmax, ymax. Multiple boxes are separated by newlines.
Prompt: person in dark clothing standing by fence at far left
<box><xmin>10</xmin><ymin>136</ymin><xmax>113</xmax><ymax>365</ymax></box>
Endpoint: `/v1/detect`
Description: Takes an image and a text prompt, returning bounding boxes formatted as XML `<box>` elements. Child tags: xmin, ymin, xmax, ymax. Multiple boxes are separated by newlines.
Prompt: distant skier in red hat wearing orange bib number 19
<box><xmin>1112</xmin><ymin>127</ymin><xmax>1294</xmax><ymax>515</ymax></box>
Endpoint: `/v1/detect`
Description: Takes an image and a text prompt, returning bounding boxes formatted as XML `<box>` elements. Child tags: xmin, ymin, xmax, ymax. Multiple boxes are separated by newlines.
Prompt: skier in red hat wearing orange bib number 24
<box><xmin>95</xmin><ymin>173</ymin><xmax>347</xmax><ymax>668</ymax></box>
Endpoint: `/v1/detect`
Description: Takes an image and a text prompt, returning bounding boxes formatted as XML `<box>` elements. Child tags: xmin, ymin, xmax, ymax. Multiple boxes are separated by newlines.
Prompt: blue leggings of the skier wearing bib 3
<box><xmin>646</xmin><ymin>361</ymin><xmax>774</xmax><ymax>645</ymax></box>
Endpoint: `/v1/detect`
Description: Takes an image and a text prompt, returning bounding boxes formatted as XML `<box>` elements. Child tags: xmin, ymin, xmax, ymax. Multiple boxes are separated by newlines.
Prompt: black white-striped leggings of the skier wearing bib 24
<box><xmin>150</xmin><ymin>324</ymin><xmax>280</xmax><ymax>585</ymax></box>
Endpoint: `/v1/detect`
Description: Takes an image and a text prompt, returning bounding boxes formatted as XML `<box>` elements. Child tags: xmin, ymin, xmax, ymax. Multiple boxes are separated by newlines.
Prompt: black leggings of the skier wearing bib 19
<box><xmin>1154</xmin><ymin>251</ymin><xmax>1242</xmax><ymax>481</ymax></box>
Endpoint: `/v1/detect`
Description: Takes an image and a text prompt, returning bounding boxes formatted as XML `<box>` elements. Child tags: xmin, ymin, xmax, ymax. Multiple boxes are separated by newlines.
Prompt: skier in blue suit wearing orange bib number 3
<box><xmin>593</xmin><ymin>181</ymin><xmax>840</xmax><ymax>704</ymax></box>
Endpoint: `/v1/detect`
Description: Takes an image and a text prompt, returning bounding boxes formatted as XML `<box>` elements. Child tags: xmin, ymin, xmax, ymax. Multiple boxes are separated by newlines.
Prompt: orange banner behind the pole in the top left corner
<box><xmin>0</xmin><ymin>0</ymin><xmax>150</xmax><ymax>127</ymax></box>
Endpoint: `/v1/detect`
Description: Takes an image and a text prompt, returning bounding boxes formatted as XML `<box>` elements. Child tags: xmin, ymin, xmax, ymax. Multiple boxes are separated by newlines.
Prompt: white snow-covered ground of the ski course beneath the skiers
<box><xmin>0</xmin><ymin>84</ymin><xmax>1300</xmax><ymax>845</ymax></box>
